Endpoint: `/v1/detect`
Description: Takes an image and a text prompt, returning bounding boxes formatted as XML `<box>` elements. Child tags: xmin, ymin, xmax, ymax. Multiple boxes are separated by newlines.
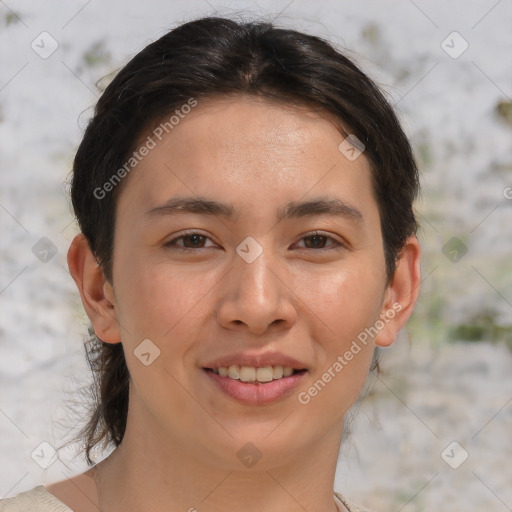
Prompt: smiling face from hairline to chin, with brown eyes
<box><xmin>85</xmin><ymin>97</ymin><xmax>412</xmax><ymax>467</ymax></box>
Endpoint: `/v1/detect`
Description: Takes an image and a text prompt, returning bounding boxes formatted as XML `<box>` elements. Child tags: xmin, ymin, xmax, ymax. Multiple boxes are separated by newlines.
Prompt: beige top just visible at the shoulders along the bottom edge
<box><xmin>0</xmin><ymin>485</ymin><xmax>367</xmax><ymax>512</ymax></box>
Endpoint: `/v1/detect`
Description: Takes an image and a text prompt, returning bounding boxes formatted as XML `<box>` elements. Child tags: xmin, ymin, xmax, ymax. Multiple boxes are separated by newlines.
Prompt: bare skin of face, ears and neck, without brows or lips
<box><xmin>48</xmin><ymin>96</ymin><xmax>420</xmax><ymax>512</ymax></box>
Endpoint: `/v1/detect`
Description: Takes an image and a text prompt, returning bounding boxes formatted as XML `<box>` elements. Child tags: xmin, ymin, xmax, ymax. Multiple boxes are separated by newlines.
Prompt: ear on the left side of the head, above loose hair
<box><xmin>68</xmin><ymin>233</ymin><xmax>121</xmax><ymax>343</ymax></box>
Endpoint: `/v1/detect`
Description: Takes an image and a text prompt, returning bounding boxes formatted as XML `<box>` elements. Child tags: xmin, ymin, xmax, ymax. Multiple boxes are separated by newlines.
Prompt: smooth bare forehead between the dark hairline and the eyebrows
<box><xmin>120</xmin><ymin>96</ymin><xmax>373</xmax><ymax>224</ymax></box>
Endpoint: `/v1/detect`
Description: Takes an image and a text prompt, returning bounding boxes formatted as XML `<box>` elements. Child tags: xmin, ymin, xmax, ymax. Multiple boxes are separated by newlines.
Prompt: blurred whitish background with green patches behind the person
<box><xmin>0</xmin><ymin>0</ymin><xmax>512</xmax><ymax>512</ymax></box>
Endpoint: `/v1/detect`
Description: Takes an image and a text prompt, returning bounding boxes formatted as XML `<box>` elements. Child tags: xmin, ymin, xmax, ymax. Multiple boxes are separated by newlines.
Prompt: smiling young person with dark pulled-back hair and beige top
<box><xmin>0</xmin><ymin>18</ymin><xmax>420</xmax><ymax>512</ymax></box>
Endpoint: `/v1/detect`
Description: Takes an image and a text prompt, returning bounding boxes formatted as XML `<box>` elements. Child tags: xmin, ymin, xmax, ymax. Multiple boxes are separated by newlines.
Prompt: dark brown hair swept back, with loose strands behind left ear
<box><xmin>71</xmin><ymin>17</ymin><xmax>419</xmax><ymax>464</ymax></box>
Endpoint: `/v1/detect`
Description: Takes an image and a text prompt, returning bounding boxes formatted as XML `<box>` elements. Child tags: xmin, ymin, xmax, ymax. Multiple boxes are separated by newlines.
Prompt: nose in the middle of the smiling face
<box><xmin>217</xmin><ymin>249</ymin><xmax>297</xmax><ymax>335</ymax></box>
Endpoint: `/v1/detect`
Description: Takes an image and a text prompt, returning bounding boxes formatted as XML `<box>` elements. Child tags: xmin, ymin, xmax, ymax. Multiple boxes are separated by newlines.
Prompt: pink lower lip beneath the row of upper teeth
<box><xmin>203</xmin><ymin>369</ymin><xmax>307</xmax><ymax>405</ymax></box>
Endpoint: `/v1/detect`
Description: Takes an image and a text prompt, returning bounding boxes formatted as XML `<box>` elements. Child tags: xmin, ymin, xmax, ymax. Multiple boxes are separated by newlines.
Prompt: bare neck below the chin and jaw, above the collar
<box><xmin>92</xmin><ymin>394</ymin><xmax>342</xmax><ymax>512</ymax></box>
